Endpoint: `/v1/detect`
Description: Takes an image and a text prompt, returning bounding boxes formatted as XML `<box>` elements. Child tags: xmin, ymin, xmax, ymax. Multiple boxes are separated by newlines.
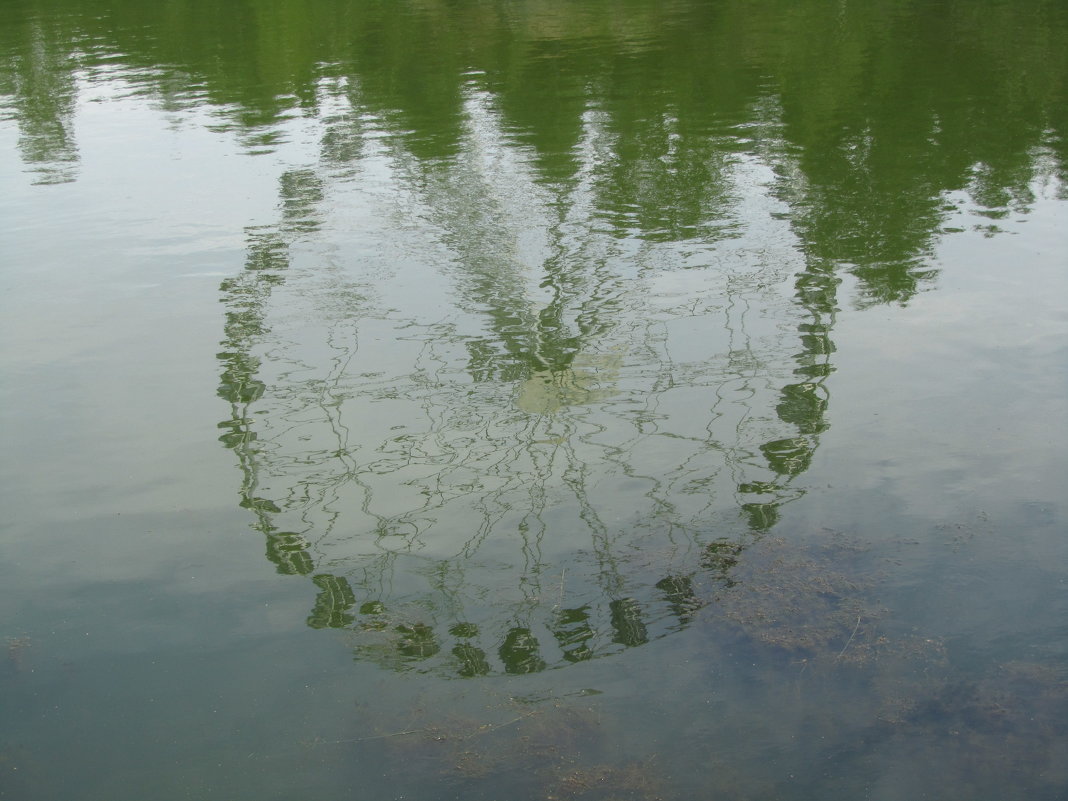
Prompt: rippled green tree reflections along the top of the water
<box><xmin>0</xmin><ymin>0</ymin><xmax>1068</xmax><ymax>275</ymax></box>
